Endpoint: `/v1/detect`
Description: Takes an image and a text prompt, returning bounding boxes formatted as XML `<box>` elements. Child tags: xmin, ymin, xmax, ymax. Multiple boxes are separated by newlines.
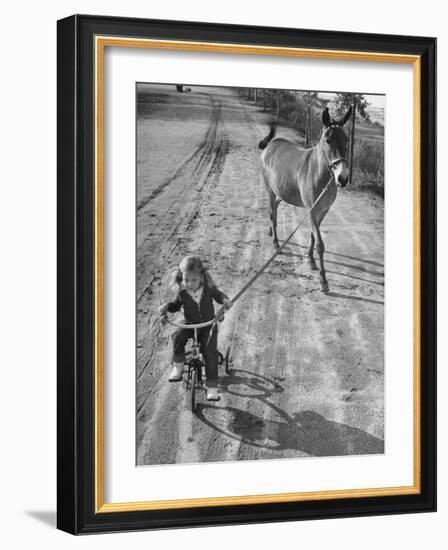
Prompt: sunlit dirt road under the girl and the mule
<box><xmin>136</xmin><ymin>85</ymin><xmax>384</xmax><ymax>465</ymax></box>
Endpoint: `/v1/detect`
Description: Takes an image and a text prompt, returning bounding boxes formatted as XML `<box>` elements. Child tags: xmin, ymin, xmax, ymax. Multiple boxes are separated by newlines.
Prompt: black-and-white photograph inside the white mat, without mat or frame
<box><xmin>136</xmin><ymin>82</ymin><xmax>387</xmax><ymax>466</ymax></box>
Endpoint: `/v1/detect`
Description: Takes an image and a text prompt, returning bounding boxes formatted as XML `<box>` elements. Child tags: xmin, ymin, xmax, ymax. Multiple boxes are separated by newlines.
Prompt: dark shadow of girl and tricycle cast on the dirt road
<box><xmin>197</xmin><ymin>369</ymin><xmax>384</xmax><ymax>456</ymax></box>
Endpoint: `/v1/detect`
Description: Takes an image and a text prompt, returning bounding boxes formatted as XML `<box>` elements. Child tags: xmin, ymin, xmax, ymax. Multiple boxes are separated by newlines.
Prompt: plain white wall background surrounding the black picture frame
<box><xmin>0</xmin><ymin>0</ymin><xmax>440</xmax><ymax>550</ymax></box>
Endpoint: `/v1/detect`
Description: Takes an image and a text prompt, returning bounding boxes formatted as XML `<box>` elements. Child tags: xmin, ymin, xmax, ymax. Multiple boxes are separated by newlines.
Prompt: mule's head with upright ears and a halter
<box><xmin>322</xmin><ymin>107</ymin><xmax>352</xmax><ymax>187</ymax></box>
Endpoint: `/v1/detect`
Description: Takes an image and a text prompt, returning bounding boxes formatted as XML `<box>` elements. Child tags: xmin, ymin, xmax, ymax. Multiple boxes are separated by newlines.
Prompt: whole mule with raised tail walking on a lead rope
<box><xmin>259</xmin><ymin>107</ymin><xmax>352</xmax><ymax>292</ymax></box>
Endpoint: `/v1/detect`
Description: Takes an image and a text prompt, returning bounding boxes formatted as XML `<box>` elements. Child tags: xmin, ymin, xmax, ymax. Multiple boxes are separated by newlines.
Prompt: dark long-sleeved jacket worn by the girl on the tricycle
<box><xmin>168</xmin><ymin>283</ymin><xmax>228</xmax><ymax>324</ymax></box>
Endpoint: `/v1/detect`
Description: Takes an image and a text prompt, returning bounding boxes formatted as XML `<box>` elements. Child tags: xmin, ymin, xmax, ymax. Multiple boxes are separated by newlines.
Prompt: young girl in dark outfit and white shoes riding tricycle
<box><xmin>159</xmin><ymin>256</ymin><xmax>232</xmax><ymax>401</ymax></box>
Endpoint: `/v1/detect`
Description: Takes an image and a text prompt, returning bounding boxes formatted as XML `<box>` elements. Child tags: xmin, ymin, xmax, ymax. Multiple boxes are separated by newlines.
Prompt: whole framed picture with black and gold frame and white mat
<box><xmin>58</xmin><ymin>15</ymin><xmax>436</xmax><ymax>534</ymax></box>
